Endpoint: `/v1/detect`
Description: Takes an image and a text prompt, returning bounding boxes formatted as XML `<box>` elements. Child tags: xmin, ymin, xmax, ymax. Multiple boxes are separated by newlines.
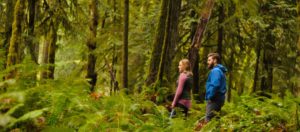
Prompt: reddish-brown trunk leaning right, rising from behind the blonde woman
<box><xmin>188</xmin><ymin>0</ymin><xmax>215</xmax><ymax>70</ymax></box>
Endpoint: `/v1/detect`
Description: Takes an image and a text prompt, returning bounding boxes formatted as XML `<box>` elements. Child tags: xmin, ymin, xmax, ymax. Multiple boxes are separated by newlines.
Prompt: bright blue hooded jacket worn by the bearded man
<box><xmin>205</xmin><ymin>64</ymin><xmax>227</xmax><ymax>102</ymax></box>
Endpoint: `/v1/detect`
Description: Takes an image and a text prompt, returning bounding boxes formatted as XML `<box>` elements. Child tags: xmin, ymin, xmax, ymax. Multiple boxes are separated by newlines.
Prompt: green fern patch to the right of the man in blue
<box><xmin>209</xmin><ymin>91</ymin><xmax>299</xmax><ymax>131</ymax></box>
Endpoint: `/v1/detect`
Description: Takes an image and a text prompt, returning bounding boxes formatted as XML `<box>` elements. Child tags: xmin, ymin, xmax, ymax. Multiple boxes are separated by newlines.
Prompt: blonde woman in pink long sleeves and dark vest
<box><xmin>171</xmin><ymin>59</ymin><xmax>193</xmax><ymax>117</ymax></box>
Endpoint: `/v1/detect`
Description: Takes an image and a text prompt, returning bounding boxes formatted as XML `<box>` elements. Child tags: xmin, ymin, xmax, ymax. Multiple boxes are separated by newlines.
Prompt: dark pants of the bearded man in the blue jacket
<box><xmin>205</xmin><ymin>101</ymin><xmax>224</xmax><ymax>122</ymax></box>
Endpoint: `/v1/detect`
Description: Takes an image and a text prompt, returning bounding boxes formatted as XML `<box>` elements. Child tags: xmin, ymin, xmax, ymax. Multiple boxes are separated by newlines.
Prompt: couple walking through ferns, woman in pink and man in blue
<box><xmin>171</xmin><ymin>53</ymin><xmax>227</xmax><ymax>126</ymax></box>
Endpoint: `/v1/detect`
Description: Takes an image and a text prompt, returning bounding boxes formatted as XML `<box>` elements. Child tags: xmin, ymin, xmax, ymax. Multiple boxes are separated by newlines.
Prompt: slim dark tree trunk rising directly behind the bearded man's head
<box><xmin>218</xmin><ymin>3</ymin><xmax>225</xmax><ymax>62</ymax></box>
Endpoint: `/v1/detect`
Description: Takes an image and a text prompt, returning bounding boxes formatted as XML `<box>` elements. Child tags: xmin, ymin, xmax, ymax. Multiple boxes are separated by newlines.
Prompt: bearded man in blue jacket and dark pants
<box><xmin>205</xmin><ymin>53</ymin><xmax>227</xmax><ymax>122</ymax></box>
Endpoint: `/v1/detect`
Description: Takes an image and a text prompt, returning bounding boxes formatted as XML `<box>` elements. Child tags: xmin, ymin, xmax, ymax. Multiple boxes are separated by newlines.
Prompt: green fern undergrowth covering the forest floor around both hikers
<box><xmin>0</xmin><ymin>73</ymin><xmax>300</xmax><ymax>131</ymax></box>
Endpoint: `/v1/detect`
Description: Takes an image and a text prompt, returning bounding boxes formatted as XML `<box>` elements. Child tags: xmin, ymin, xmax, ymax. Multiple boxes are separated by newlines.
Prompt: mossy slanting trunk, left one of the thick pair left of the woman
<box><xmin>146</xmin><ymin>0</ymin><xmax>170</xmax><ymax>86</ymax></box>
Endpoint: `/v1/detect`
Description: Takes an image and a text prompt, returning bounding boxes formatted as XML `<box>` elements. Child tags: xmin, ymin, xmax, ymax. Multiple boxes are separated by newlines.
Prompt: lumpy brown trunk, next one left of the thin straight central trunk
<box><xmin>86</xmin><ymin>0</ymin><xmax>98</xmax><ymax>92</ymax></box>
